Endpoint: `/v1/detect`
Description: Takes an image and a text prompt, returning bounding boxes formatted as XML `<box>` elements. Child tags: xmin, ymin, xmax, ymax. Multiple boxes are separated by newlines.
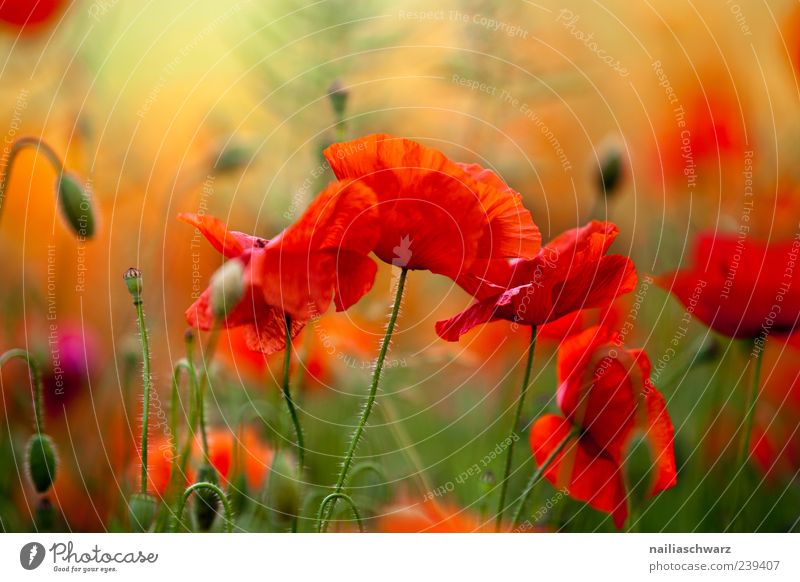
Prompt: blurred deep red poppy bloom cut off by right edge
<box><xmin>657</xmin><ymin>233</ymin><xmax>800</xmax><ymax>338</ymax></box>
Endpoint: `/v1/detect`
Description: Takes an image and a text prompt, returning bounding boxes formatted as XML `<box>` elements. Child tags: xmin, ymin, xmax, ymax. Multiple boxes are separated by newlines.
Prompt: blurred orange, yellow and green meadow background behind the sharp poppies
<box><xmin>0</xmin><ymin>0</ymin><xmax>800</xmax><ymax>531</ymax></box>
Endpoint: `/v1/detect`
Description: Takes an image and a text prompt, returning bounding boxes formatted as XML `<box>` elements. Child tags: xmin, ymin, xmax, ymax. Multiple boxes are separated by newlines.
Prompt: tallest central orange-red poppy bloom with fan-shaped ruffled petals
<box><xmin>325</xmin><ymin>134</ymin><xmax>541</xmax><ymax>278</ymax></box>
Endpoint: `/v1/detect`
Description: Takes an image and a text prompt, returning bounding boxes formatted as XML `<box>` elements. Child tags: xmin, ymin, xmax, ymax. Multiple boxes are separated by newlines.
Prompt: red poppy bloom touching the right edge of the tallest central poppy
<box><xmin>436</xmin><ymin>221</ymin><xmax>637</xmax><ymax>341</ymax></box>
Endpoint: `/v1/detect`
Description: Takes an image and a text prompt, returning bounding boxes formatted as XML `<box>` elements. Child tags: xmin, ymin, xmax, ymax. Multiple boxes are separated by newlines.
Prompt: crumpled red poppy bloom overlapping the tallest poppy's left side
<box><xmin>178</xmin><ymin>181</ymin><xmax>378</xmax><ymax>354</ymax></box>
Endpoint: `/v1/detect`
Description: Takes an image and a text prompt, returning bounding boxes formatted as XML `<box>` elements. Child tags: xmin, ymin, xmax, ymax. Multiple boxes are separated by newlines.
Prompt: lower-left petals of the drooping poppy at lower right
<box><xmin>530</xmin><ymin>414</ymin><xmax>628</xmax><ymax>529</ymax></box>
